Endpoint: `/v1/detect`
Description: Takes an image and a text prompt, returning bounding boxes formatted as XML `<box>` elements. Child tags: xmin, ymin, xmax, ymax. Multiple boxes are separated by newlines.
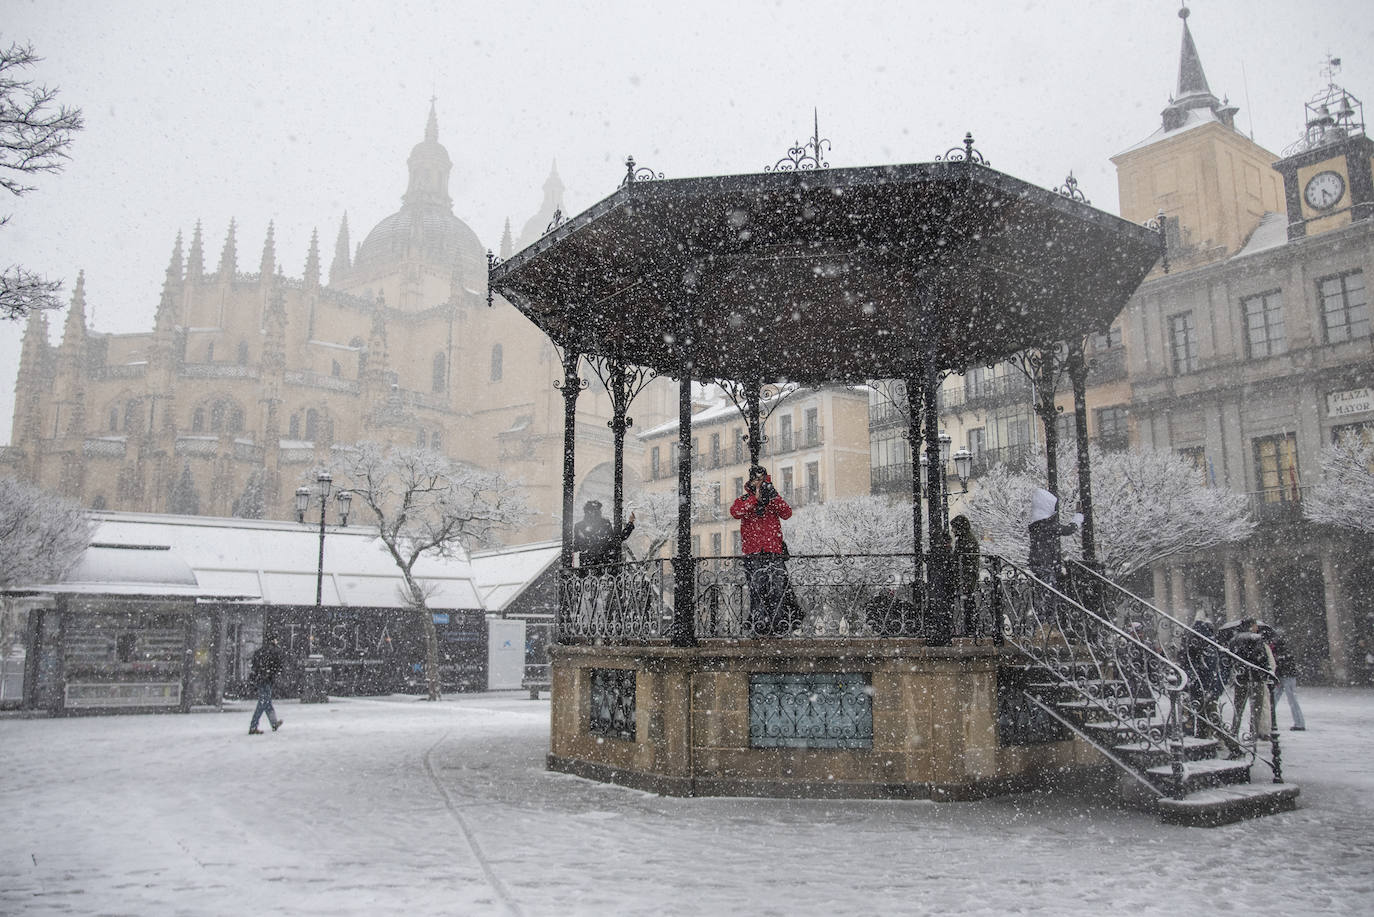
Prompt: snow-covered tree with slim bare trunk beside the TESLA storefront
<box><xmin>334</xmin><ymin>443</ymin><xmax>529</xmax><ymax>700</ymax></box>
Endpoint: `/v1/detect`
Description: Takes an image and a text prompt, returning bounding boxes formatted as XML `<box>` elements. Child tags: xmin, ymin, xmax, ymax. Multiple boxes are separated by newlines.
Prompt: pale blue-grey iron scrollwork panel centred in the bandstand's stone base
<box><xmin>749</xmin><ymin>672</ymin><xmax>872</xmax><ymax>748</ymax></box>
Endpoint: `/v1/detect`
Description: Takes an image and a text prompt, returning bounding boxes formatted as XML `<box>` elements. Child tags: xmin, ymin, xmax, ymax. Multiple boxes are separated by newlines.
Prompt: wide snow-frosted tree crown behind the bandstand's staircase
<box><xmin>967</xmin><ymin>447</ymin><xmax>1254</xmax><ymax>579</ymax></box>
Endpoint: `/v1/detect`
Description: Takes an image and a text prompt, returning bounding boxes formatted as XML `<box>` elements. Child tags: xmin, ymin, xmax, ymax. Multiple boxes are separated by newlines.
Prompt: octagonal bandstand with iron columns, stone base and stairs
<box><xmin>489</xmin><ymin>140</ymin><xmax>1296</xmax><ymax>824</ymax></box>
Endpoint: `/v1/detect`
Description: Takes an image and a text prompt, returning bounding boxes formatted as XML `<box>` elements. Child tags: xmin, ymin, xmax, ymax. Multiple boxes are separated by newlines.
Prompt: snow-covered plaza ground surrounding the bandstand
<box><xmin>0</xmin><ymin>687</ymin><xmax>1374</xmax><ymax>916</ymax></box>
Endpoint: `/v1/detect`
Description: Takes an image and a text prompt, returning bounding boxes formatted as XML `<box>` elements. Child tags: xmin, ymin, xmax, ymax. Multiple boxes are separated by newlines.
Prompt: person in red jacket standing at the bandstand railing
<box><xmin>730</xmin><ymin>465</ymin><xmax>791</xmax><ymax>637</ymax></box>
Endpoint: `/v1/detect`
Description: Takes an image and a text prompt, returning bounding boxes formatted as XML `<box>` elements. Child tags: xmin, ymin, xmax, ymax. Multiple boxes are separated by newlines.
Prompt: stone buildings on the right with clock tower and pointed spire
<box><xmin>871</xmin><ymin>11</ymin><xmax>1374</xmax><ymax>682</ymax></box>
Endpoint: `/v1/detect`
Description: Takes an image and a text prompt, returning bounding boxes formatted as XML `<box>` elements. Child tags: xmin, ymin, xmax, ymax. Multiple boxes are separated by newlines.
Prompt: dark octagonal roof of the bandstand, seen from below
<box><xmin>491</xmin><ymin>150</ymin><xmax>1161</xmax><ymax>382</ymax></box>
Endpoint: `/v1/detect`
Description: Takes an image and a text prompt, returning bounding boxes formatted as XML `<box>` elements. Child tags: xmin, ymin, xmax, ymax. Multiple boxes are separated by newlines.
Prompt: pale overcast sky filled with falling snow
<box><xmin>0</xmin><ymin>0</ymin><xmax>1374</xmax><ymax>441</ymax></box>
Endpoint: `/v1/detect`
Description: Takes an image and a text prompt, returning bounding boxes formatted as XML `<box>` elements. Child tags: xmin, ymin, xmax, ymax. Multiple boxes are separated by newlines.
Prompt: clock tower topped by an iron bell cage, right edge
<box><xmin>1274</xmin><ymin>58</ymin><xmax>1374</xmax><ymax>239</ymax></box>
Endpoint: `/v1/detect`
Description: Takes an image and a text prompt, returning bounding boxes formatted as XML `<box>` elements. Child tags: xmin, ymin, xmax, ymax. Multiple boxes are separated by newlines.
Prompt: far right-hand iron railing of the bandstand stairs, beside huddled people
<box><xmin>1065</xmin><ymin>561</ymin><xmax>1283</xmax><ymax>780</ymax></box>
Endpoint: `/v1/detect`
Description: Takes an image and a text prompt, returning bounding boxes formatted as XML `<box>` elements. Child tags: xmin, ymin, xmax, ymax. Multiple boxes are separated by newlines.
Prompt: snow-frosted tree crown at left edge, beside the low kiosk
<box><xmin>0</xmin><ymin>477</ymin><xmax>91</xmax><ymax>656</ymax></box>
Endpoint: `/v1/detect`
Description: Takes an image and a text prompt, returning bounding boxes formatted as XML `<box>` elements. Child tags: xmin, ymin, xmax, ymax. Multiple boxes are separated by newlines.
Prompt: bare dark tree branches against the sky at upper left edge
<box><xmin>0</xmin><ymin>44</ymin><xmax>84</xmax><ymax>319</ymax></box>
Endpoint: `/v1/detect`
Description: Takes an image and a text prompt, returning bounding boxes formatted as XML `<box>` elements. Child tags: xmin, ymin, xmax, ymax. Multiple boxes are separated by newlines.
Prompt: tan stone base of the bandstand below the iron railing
<box><xmin>548</xmin><ymin>639</ymin><xmax>1105</xmax><ymax>800</ymax></box>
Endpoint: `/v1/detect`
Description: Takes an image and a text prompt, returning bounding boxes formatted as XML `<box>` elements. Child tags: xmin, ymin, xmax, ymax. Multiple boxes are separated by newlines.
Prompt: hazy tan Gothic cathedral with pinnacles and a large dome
<box><xmin>0</xmin><ymin>106</ymin><xmax>673</xmax><ymax>540</ymax></box>
